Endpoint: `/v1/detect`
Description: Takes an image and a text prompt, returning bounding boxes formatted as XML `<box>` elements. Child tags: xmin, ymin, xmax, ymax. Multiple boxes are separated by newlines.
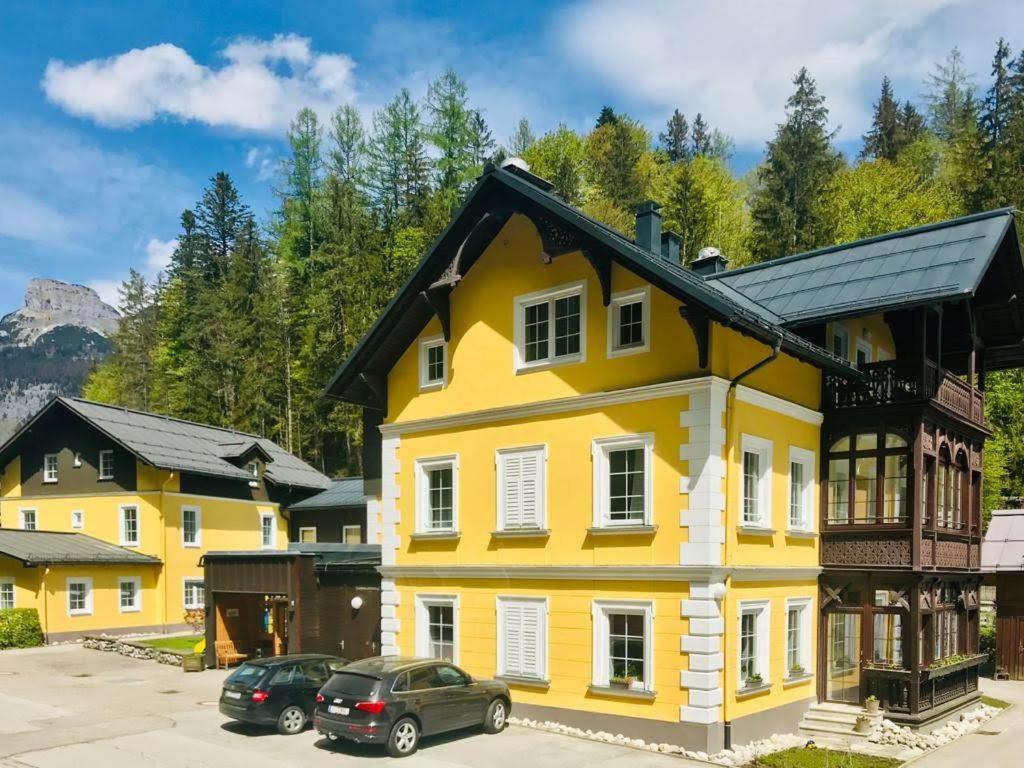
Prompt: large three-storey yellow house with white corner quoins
<box><xmin>328</xmin><ymin>165</ymin><xmax>856</xmax><ymax>750</ymax></box>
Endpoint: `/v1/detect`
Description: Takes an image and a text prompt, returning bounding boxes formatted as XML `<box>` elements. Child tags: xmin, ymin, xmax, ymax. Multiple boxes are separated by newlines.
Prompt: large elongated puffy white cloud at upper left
<box><xmin>42</xmin><ymin>35</ymin><xmax>354</xmax><ymax>132</ymax></box>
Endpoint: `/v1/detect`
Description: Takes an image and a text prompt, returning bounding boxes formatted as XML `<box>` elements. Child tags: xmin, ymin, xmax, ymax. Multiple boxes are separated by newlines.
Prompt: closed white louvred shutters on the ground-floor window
<box><xmin>498</xmin><ymin>597</ymin><xmax>548</xmax><ymax>680</ymax></box>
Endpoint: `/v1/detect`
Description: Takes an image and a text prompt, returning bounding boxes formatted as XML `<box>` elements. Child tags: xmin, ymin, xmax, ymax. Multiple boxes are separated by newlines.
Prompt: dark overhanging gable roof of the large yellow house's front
<box><xmin>326</xmin><ymin>167</ymin><xmax>859</xmax><ymax>404</ymax></box>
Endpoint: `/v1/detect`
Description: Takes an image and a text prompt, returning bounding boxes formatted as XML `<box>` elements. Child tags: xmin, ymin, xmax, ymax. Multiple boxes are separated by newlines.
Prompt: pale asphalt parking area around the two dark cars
<box><xmin>0</xmin><ymin>645</ymin><xmax>706</xmax><ymax>768</ymax></box>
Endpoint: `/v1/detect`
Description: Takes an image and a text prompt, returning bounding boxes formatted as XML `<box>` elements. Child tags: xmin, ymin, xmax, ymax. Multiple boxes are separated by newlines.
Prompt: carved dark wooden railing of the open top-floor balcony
<box><xmin>824</xmin><ymin>360</ymin><xmax>985</xmax><ymax>424</ymax></box>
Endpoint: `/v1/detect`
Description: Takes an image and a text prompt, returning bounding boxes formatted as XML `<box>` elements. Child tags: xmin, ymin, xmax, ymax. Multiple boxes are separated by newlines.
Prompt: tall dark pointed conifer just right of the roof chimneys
<box><xmin>751</xmin><ymin>69</ymin><xmax>843</xmax><ymax>261</ymax></box>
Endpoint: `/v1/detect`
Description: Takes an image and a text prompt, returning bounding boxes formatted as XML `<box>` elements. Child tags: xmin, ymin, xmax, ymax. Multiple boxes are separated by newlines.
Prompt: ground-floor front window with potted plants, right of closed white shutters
<box><xmin>593</xmin><ymin>600</ymin><xmax>654</xmax><ymax>691</ymax></box>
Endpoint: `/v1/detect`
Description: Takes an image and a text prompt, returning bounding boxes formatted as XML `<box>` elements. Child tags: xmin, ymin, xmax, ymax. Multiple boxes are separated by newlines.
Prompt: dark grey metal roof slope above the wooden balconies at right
<box><xmin>708</xmin><ymin>208</ymin><xmax>1014</xmax><ymax>326</ymax></box>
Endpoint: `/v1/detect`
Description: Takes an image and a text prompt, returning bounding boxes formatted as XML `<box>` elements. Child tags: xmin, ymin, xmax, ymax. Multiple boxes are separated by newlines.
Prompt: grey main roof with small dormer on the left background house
<box><xmin>0</xmin><ymin>397</ymin><xmax>331</xmax><ymax>489</ymax></box>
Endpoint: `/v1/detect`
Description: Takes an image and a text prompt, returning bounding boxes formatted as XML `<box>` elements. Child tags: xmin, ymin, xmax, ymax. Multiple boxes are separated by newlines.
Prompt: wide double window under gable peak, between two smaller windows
<box><xmin>514</xmin><ymin>282</ymin><xmax>587</xmax><ymax>371</ymax></box>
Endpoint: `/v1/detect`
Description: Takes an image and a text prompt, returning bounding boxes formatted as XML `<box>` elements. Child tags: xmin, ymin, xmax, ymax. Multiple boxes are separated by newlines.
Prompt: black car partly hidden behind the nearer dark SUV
<box><xmin>220</xmin><ymin>653</ymin><xmax>348</xmax><ymax>736</ymax></box>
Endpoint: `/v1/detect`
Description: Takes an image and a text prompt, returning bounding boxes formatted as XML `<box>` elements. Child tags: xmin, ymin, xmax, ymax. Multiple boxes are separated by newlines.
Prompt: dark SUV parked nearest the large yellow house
<box><xmin>313</xmin><ymin>656</ymin><xmax>512</xmax><ymax>758</ymax></box>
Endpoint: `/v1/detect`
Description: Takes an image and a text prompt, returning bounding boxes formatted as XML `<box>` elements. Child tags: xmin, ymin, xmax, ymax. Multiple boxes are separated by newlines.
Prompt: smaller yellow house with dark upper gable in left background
<box><xmin>0</xmin><ymin>397</ymin><xmax>330</xmax><ymax>641</ymax></box>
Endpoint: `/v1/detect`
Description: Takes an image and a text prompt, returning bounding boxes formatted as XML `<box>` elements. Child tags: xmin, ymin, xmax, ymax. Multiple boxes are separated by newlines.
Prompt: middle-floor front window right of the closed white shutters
<box><xmin>592</xmin><ymin>434</ymin><xmax>654</xmax><ymax>527</ymax></box>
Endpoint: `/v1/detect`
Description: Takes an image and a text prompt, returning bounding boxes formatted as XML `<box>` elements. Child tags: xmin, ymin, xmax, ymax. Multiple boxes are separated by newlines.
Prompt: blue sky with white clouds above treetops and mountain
<box><xmin>0</xmin><ymin>0</ymin><xmax>1024</xmax><ymax>314</ymax></box>
